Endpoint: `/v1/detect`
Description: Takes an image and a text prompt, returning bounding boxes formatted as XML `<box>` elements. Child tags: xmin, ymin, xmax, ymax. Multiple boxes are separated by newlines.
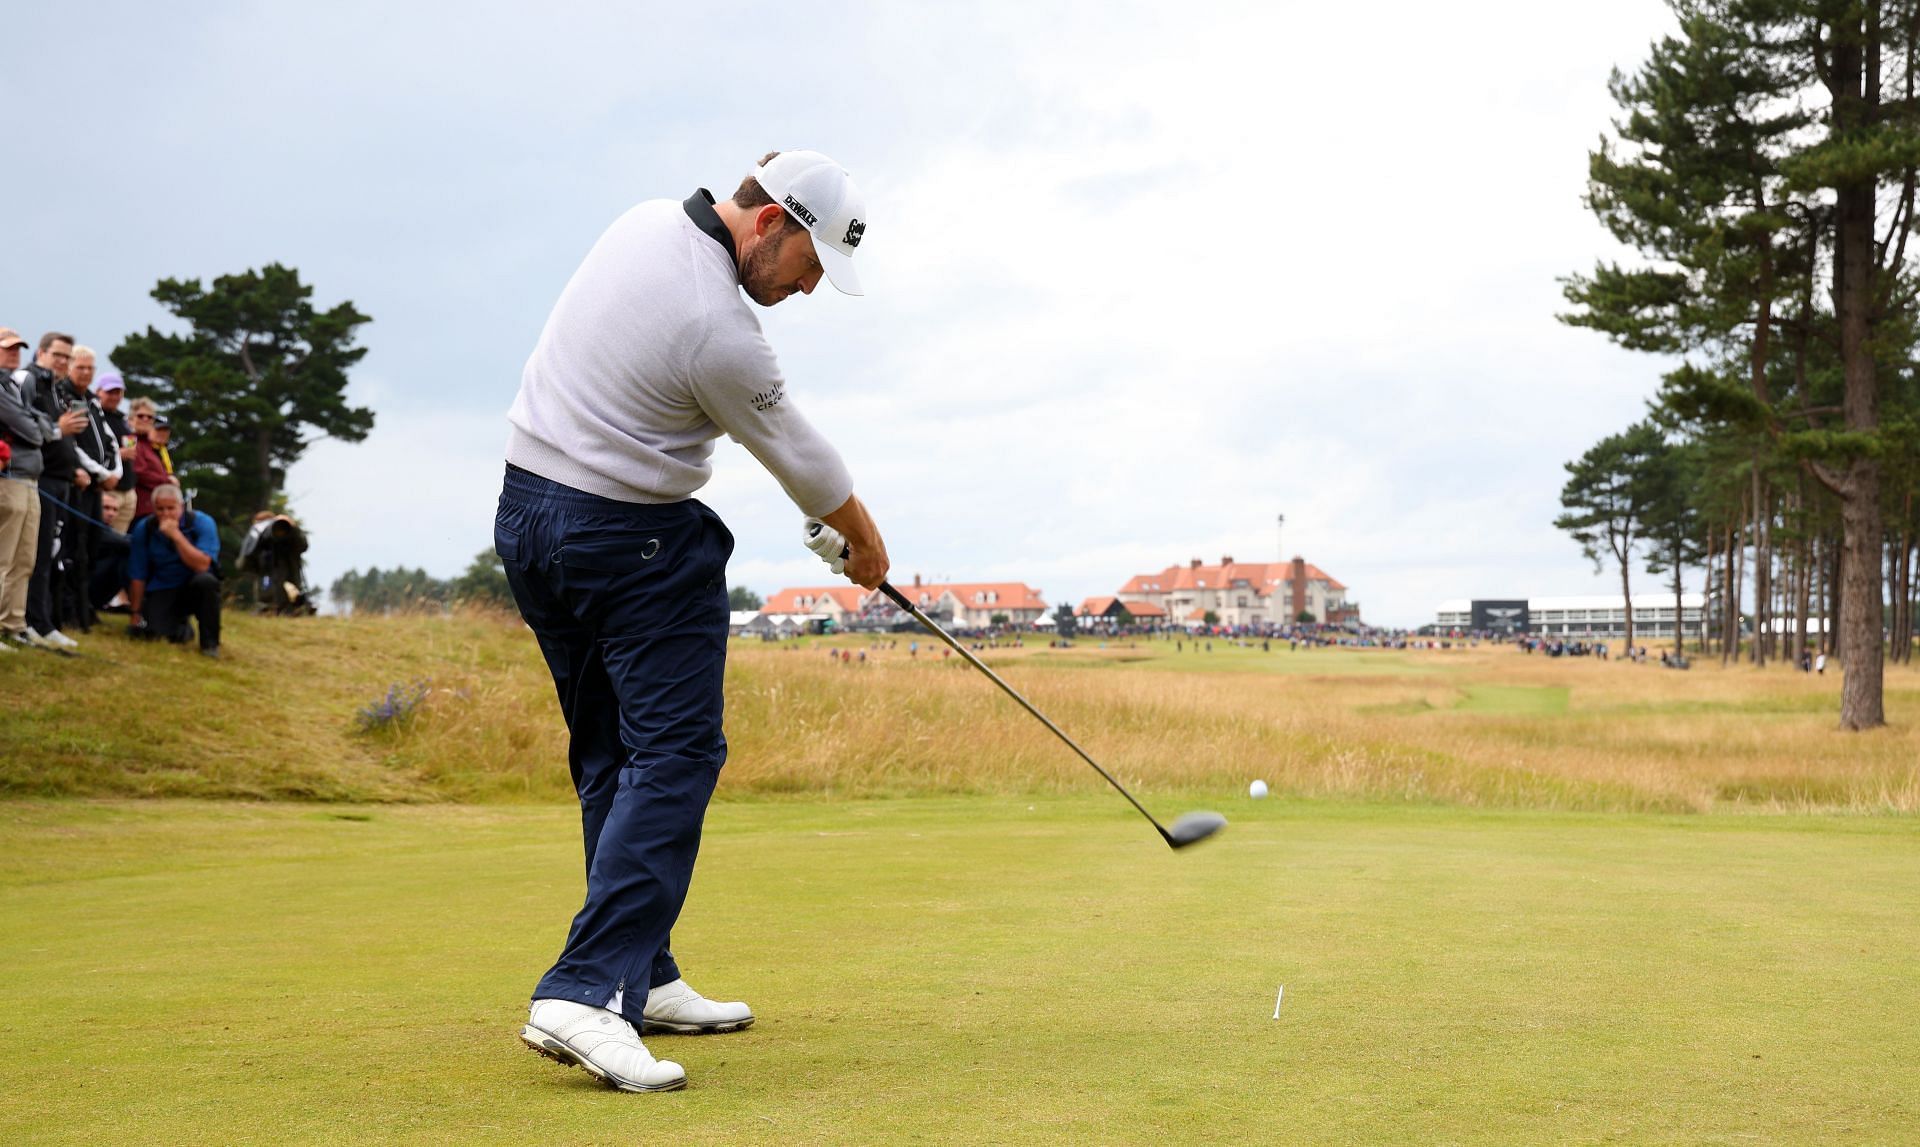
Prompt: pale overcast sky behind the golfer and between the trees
<box><xmin>0</xmin><ymin>0</ymin><xmax>1670</xmax><ymax>624</ymax></box>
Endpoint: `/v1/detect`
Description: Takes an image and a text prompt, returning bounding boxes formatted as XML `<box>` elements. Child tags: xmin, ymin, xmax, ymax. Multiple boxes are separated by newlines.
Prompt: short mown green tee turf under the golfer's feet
<box><xmin>0</xmin><ymin>792</ymin><xmax>1920</xmax><ymax>1143</ymax></box>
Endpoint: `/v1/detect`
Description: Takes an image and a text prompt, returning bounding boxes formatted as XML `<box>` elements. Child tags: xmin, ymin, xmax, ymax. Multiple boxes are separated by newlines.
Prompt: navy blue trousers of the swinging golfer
<box><xmin>493</xmin><ymin>467</ymin><xmax>733</xmax><ymax>1024</ymax></box>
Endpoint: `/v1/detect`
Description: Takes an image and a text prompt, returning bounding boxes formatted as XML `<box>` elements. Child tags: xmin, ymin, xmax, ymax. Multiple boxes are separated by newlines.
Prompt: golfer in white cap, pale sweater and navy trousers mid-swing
<box><xmin>493</xmin><ymin>152</ymin><xmax>887</xmax><ymax>1091</ymax></box>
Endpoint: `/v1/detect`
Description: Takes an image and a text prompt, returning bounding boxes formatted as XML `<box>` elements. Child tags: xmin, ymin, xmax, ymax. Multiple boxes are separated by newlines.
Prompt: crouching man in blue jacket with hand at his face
<box><xmin>127</xmin><ymin>482</ymin><xmax>221</xmax><ymax>657</ymax></box>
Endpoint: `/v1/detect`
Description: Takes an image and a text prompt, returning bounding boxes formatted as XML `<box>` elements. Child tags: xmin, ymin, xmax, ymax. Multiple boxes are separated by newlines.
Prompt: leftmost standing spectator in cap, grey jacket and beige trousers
<box><xmin>0</xmin><ymin>327</ymin><xmax>77</xmax><ymax>649</ymax></box>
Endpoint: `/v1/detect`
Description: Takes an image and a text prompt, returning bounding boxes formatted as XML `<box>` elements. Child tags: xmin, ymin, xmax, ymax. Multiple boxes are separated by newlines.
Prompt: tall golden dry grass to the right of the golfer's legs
<box><xmin>698</xmin><ymin>634</ymin><xmax>1920</xmax><ymax>813</ymax></box>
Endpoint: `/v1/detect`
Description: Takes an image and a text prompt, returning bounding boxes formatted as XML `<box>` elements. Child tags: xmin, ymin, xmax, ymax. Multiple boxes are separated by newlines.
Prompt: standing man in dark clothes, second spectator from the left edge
<box><xmin>13</xmin><ymin>330</ymin><xmax>88</xmax><ymax>649</ymax></box>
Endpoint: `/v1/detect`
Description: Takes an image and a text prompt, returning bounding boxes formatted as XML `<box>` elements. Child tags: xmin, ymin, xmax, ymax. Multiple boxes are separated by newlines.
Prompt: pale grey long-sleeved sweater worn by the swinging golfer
<box><xmin>507</xmin><ymin>192</ymin><xmax>852</xmax><ymax>515</ymax></box>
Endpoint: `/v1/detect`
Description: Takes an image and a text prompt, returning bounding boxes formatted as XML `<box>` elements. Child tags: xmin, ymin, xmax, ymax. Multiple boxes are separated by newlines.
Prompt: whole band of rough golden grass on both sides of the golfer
<box><xmin>0</xmin><ymin>613</ymin><xmax>1920</xmax><ymax>813</ymax></box>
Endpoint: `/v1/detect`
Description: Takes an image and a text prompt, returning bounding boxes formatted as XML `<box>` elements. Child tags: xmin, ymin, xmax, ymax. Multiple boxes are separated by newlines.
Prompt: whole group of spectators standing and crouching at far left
<box><xmin>0</xmin><ymin>327</ymin><xmax>221</xmax><ymax>657</ymax></box>
